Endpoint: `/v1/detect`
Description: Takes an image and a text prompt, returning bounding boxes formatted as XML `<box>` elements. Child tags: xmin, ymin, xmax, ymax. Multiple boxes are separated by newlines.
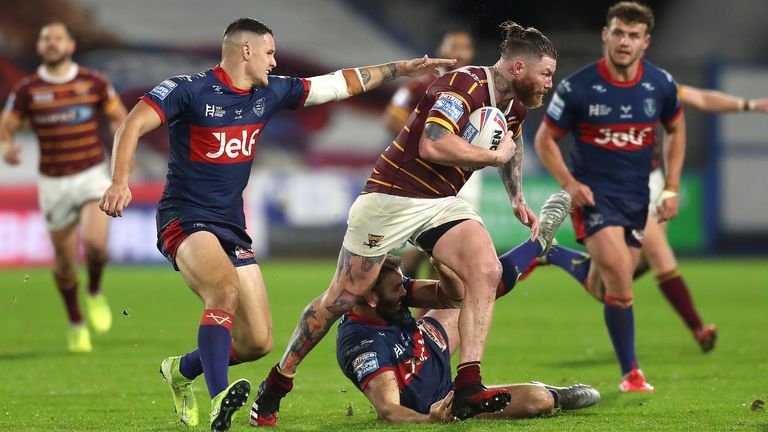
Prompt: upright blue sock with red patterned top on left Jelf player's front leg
<box><xmin>197</xmin><ymin>309</ymin><xmax>232</xmax><ymax>399</ymax></box>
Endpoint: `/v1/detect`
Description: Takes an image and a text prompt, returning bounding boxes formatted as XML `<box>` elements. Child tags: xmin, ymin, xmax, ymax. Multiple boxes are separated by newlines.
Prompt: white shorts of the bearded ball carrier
<box><xmin>343</xmin><ymin>193</ymin><xmax>483</xmax><ymax>257</ymax></box>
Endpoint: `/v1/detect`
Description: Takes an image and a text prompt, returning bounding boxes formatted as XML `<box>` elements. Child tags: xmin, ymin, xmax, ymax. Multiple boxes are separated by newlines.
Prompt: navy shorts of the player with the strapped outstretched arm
<box><xmin>157</xmin><ymin>219</ymin><xmax>257</xmax><ymax>271</ymax></box>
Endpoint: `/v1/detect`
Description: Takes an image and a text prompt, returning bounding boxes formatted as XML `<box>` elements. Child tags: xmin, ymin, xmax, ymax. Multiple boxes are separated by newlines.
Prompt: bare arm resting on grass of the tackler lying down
<box><xmin>363</xmin><ymin>371</ymin><xmax>453</xmax><ymax>423</ymax></box>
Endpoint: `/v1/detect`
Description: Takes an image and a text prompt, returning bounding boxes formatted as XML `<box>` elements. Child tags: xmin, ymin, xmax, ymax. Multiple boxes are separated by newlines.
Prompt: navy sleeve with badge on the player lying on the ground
<box><xmin>338</xmin><ymin>329</ymin><xmax>395</xmax><ymax>390</ymax></box>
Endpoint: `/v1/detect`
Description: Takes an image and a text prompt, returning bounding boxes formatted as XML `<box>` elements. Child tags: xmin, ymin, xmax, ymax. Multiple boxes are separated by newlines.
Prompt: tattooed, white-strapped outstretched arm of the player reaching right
<box><xmin>304</xmin><ymin>56</ymin><xmax>456</xmax><ymax>106</ymax></box>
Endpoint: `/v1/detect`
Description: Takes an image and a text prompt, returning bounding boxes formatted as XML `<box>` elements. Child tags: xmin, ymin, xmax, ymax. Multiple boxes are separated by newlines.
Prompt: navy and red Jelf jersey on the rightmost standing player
<box><xmin>544</xmin><ymin>59</ymin><xmax>682</xmax><ymax>203</ymax></box>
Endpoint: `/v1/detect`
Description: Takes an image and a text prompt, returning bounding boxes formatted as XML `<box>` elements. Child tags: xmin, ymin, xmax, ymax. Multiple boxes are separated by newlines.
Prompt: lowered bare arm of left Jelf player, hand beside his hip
<box><xmin>99</xmin><ymin>101</ymin><xmax>162</xmax><ymax>217</ymax></box>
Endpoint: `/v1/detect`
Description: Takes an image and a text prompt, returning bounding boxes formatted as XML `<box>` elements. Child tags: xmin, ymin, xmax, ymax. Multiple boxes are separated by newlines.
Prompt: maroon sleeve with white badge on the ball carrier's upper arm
<box><xmin>426</xmin><ymin>72</ymin><xmax>481</xmax><ymax>135</ymax></box>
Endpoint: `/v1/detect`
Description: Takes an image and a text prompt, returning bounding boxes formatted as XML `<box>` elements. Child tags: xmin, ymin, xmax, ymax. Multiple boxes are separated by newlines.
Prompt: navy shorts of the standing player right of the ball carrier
<box><xmin>571</xmin><ymin>194</ymin><xmax>648</xmax><ymax>248</ymax></box>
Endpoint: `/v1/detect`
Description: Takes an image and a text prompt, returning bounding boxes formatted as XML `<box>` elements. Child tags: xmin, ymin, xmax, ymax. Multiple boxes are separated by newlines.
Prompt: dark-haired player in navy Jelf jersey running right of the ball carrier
<box><xmin>536</xmin><ymin>2</ymin><xmax>685</xmax><ymax>391</ymax></box>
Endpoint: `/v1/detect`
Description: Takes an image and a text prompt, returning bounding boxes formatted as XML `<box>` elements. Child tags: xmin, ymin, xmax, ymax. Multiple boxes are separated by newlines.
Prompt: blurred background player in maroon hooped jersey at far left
<box><xmin>0</xmin><ymin>21</ymin><xmax>125</xmax><ymax>352</ymax></box>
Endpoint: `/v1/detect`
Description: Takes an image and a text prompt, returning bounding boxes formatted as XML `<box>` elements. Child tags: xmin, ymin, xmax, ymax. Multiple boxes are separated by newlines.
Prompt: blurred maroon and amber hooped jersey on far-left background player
<box><xmin>5</xmin><ymin>64</ymin><xmax>119</xmax><ymax>177</ymax></box>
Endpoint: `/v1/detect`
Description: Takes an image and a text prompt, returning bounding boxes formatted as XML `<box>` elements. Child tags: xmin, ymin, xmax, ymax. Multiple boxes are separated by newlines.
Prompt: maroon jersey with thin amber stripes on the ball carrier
<box><xmin>363</xmin><ymin>66</ymin><xmax>528</xmax><ymax>198</ymax></box>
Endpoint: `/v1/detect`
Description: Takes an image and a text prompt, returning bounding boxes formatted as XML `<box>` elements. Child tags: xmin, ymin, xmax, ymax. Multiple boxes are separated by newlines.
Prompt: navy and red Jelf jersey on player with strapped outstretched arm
<box><xmin>141</xmin><ymin>66</ymin><xmax>309</xmax><ymax>229</ymax></box>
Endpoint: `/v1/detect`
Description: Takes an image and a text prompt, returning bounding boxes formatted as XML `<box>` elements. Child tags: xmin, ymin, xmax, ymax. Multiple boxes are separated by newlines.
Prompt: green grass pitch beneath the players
<box><xmin>0</xmin><ymin>260</ymin><xmax>768</xmax><ymax>431</ymax></box>
